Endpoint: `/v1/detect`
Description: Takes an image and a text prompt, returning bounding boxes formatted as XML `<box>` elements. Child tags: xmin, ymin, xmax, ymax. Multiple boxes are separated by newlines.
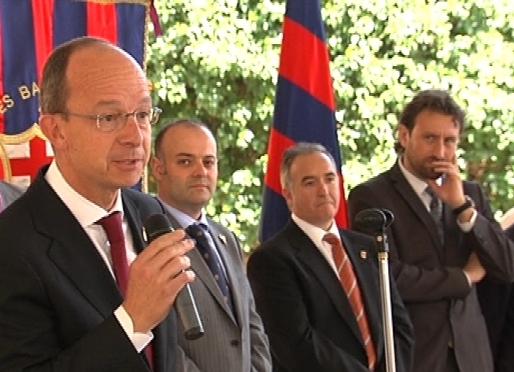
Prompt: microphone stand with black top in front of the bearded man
<box><xmin>355</xmin><ymin>208</ymin><xmax>396</xmax><ymax>372</ymax></box>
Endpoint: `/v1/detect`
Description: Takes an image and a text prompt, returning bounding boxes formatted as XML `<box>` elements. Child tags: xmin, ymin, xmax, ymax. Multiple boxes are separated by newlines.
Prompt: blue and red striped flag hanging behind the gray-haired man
<box><xmin>259</xmin><ymin>0</ymin><xmax>348</xmax><ymax>242</ymax></box>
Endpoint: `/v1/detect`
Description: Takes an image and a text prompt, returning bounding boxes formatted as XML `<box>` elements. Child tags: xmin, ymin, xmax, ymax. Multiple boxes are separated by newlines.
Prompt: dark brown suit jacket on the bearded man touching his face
<box><xmin>348</xmin><ymin>164</ymin><xmax>514</xmax><ymax>372</ymax></box>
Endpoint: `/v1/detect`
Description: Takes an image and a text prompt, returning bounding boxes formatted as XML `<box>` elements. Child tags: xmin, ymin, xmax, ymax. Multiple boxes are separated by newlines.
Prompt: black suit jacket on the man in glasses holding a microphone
<box><xmin>0</xmin><ymin>172</ymin><xmax>177</xmax><ymax>372</ymax></box>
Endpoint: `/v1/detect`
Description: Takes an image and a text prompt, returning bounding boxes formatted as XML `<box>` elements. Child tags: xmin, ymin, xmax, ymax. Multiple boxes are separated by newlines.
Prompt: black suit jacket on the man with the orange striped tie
<box><xmin>247</xmin><ymin>221</ymin><xmax>412</xmax><ymax>372</ymax></box>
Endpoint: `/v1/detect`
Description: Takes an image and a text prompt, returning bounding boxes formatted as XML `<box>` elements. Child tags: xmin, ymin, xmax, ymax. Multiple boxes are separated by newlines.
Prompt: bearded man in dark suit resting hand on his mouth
<box><xmin>348</xmin><ymin>90</ymin><xmax>514</xmax><ymax>372</ymax></box>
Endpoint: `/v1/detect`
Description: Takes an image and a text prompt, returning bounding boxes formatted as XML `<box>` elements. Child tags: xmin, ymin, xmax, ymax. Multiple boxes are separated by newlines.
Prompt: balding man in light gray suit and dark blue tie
<box><xmin>151</xmin><ymin>119</ymin><xmax>271</xmax><ymax>372</ymax></box>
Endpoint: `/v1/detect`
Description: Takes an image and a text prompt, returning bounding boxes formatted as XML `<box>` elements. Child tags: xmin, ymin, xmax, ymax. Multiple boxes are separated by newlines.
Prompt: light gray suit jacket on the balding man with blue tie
<box><xmin>164</xmin><ymin>214</ymin><xmax>271</xmax><ymax>372</ymax></box>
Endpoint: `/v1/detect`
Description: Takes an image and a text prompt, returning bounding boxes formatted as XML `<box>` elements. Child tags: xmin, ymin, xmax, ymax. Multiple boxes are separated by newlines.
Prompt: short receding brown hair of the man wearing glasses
<box><xmin>39</xmin><ymin>36</ymin><xmax>114</xmax><ymax>114</ymax></box>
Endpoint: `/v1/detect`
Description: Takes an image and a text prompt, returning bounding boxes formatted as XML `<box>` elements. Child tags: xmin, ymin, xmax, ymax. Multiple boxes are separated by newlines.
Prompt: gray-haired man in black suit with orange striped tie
<box><xmin>247</xmin><ymin>143</ymin><xmax>413</xmax><ymax>372</ymax></box>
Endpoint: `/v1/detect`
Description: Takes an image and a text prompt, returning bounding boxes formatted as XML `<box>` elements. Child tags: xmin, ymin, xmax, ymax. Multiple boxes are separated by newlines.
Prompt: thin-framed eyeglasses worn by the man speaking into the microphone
<box><xmin>55</xmin><ymin>106</ymin><xmax>162</xmax><ymax>133</ymax></box>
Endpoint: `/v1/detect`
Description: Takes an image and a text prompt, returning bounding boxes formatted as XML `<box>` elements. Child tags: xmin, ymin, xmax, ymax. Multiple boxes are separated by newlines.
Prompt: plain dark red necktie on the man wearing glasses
<box><xmin>97</xmin><ymin>211</ymin><xmax>154</xmax><ymax>370</ymax></box>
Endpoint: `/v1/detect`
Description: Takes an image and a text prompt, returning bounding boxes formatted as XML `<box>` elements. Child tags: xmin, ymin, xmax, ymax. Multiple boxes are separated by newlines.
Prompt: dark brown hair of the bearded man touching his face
<box><xmin>394</xmin><ymin>89</ymin><xmax>465</xmax><ymax>153</ymax></box>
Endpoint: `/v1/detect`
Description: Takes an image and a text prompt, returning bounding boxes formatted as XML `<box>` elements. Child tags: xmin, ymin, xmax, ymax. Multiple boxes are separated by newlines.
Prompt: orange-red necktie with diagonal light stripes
<box><xmin>323</xmin><ymin>233</ymin><xmax>377</xmax><ymax>370</ymax></box>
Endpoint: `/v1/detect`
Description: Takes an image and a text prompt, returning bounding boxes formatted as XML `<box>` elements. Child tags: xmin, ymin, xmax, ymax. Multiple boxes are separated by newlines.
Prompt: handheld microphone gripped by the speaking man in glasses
<box><xmin>144</xmin><ymin>214</ymin><xmax>205</xmax><ymax>340</ymax></box>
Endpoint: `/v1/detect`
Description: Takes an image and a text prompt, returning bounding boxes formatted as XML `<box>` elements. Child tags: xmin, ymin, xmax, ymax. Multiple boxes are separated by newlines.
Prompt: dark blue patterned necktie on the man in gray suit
<box><xmin>186</xmin><ymin>224</ymin><xmax>234</xmax><ymax>313</ymax></box>
